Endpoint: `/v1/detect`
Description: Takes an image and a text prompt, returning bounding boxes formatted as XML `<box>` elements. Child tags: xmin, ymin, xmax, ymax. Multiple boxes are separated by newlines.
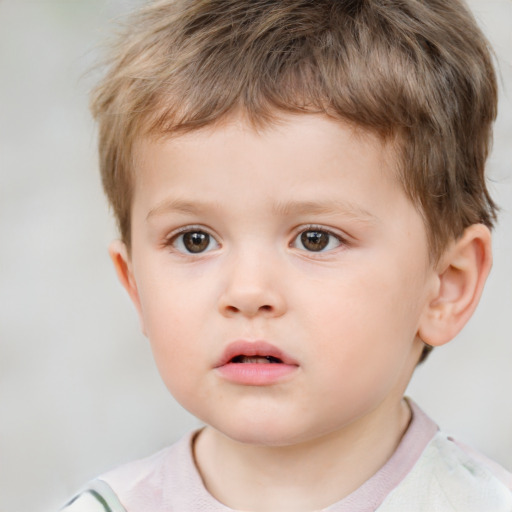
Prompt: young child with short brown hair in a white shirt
<box><xmin>65</xmin><ymin>0</ymin><xmax>512</xmax><ymax>512</ymax></box>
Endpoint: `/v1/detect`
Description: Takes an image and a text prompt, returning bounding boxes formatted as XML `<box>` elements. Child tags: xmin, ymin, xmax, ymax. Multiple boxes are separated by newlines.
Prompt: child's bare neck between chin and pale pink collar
<box><xmin>195</xmin><ymin>401</ymin><xmax>410</xmax><ymax>512</ymax></box>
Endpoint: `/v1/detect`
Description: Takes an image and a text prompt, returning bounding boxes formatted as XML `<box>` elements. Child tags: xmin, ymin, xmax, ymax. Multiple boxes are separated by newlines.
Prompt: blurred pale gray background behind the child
<box><xmin>0</xmin><ymin>0</ymin><xmax>512</xmax><ymax>512</ymax></box>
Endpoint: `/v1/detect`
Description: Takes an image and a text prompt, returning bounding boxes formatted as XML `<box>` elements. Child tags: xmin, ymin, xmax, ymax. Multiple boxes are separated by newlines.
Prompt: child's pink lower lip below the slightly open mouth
<box><xmin>217</xmin><ymin>363</ymin><xmax>298</xmax><ymax>386</ymax></box>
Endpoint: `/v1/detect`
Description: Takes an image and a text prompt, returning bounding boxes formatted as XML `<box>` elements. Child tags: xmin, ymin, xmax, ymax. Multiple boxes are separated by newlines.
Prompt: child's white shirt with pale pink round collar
<box><xmin>64</xmin><ymin>400</ymin><xmax>512</xmax><ymax>512</ymax></box>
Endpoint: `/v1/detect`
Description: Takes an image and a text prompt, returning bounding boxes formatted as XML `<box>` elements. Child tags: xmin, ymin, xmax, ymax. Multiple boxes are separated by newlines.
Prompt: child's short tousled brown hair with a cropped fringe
<box><xmin>92</xmin><ymin>0</ymin><xmax>497</xmax><ymax>258</ymax></box>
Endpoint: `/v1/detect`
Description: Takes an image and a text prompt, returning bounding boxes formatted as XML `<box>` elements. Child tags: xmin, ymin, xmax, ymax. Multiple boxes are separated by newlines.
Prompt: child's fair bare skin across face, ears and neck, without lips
<box><xmin>111</xmin><ymin>115</ymin><xmax>490</xmax><ymax>511</ymax></box>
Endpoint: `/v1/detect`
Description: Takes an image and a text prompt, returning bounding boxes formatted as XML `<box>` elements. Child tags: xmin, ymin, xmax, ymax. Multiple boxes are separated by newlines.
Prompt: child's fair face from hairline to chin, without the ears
<box><xmin>119</xmin><ymin>115</ymin><xmax>435</xmax><ymax>445</ymax></box>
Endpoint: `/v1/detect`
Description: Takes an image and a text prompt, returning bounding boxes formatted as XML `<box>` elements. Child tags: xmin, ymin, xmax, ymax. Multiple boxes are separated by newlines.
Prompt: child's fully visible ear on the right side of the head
<box><xmin>418</xmin><ymin>224</ymin><xmax>492</xmax><ymax>346</ymax></box>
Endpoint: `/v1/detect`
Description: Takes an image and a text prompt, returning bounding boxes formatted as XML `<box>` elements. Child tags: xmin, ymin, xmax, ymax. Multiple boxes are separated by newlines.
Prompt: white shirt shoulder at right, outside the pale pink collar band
<box><xmin>379</xmin><ymin>424</ymin><xmax>512</xmax><ymax>512</ymax></box>
